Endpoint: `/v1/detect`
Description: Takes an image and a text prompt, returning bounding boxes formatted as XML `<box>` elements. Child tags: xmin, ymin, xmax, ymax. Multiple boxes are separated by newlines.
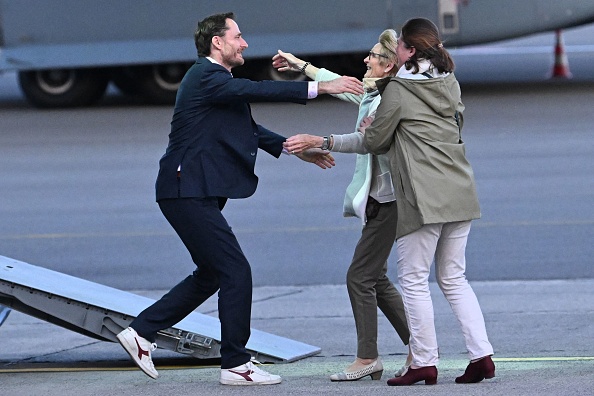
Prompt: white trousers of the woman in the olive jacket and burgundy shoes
<box><xmin>396</xmin><ymin>221</ymin><xmax>493</xmax><ymax>367</ymax></box>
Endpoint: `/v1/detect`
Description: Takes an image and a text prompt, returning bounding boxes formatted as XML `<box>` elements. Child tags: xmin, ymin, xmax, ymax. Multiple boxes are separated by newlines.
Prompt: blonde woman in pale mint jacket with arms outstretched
<box><xmin>273</xmin><ymin>29</ymin><xmax>409</xmax><ymax>381</ymax></box>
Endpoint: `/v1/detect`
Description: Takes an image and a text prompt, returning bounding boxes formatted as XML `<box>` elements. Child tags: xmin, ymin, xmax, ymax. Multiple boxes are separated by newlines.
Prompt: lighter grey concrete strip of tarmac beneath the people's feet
<box><xmin>0</xmin><ymin>280</ymin><xmax>594</xmax><ymax>396</ymax></box>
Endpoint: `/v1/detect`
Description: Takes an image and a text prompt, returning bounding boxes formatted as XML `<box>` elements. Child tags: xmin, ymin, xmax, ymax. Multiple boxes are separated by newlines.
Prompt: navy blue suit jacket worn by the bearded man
<box><xmin>156</xmin><ymin>58</ymin><xmax>308</xmax><ymax>201</ymax></box>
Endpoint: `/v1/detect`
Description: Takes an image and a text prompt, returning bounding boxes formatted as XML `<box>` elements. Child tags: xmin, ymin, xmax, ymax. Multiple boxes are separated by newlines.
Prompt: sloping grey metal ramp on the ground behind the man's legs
<box><xmin>0</xmin><ymin>256</ymin><xmax>321</xmax><ymax>363</ymax></box>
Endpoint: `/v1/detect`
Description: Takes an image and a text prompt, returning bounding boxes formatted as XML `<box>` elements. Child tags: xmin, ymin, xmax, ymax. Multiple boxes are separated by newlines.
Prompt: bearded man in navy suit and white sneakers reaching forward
<box><xmin>117</xmin><ymin>13</ymin><xmax>363</xmax><ymax>385</ymax></box>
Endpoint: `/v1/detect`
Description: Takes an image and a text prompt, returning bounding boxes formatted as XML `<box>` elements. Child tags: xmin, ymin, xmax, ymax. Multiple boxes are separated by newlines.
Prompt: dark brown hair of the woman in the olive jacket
<box><xmin>399</xmin><ymin>18</ymin><xmax>455</xmax><ymax>73</ymax></box>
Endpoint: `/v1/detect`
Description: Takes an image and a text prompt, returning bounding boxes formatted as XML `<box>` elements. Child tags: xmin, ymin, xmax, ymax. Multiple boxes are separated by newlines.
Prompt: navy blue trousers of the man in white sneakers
<box><xmin>130</xmin><ymin>197</ymin><xmax>252</xmax><ymax>368</ymax></box>
